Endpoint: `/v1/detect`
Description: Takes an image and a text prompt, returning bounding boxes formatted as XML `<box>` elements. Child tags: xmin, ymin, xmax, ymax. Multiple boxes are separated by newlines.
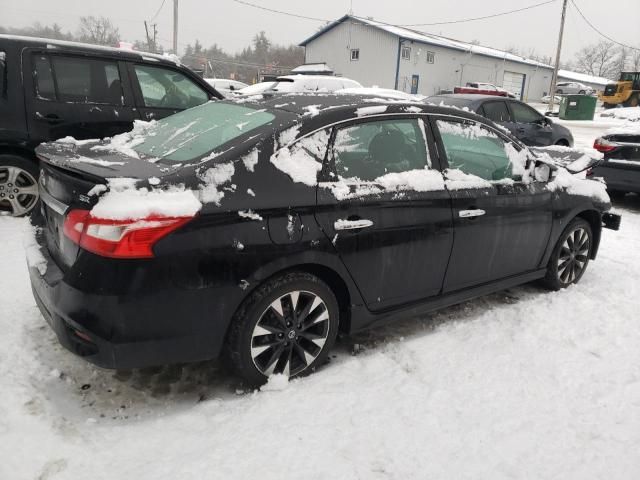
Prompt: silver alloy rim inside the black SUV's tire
<box><xmin>0</xmin><ymin>165</ymin><xmax>38</xmax><ymax>217</ymax></box>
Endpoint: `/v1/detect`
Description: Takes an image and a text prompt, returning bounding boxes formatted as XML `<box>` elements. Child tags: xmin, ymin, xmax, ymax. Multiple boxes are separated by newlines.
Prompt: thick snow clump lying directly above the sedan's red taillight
<box><xmin>91</xmin><ymin>178</ymin><xmax>202</xmax><ymax>220</ymax></box>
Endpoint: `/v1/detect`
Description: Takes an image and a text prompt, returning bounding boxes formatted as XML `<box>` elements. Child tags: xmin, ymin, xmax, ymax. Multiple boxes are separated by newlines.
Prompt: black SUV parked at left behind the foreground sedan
<box><xmin>0</xmin><ymin>35</ymin><xmax>222</xmax><ymax>216</ymax></box>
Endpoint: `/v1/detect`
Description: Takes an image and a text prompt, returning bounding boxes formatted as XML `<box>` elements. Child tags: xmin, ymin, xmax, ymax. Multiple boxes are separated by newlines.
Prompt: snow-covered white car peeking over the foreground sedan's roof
<box><xmin>237</xmin><ymin>75</ymin><xmax>362</xmax><ymax>95</ymax></box>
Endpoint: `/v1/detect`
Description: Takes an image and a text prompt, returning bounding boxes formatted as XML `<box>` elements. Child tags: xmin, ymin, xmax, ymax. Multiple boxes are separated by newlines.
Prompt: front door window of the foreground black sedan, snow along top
<box><xmin>436</xmin><ymin>120</ymin><xmax>512</xmax><ymax>181</ymax></box>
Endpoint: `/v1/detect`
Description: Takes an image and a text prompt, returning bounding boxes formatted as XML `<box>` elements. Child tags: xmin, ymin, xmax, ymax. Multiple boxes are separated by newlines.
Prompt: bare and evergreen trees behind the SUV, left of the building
<box><xmin>0</xmin><ymin>16</ymin><xmax>304</xmax><ymax>83</ymax></box>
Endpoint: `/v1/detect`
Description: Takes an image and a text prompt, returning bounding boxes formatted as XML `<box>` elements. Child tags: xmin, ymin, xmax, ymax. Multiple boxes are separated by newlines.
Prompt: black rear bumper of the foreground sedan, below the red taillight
<box><xmin>29</xmin><ymin>231</ymin><xmax>232</xmax><ymax>369</ymax></box>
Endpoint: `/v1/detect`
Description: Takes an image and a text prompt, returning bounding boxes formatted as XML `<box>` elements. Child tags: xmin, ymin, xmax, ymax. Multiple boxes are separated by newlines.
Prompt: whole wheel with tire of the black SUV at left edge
<box><xmin>0</xmin><ymin>154</ymin><xmax>39</xmax><ymax>217</ymax></box>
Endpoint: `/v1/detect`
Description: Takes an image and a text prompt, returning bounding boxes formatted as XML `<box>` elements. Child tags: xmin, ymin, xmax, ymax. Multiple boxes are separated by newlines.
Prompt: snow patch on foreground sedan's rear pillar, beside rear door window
<box><xmin>270</xmin><ymin>129</ymin><xmax>329</xmax><ymax>187</ymax></box>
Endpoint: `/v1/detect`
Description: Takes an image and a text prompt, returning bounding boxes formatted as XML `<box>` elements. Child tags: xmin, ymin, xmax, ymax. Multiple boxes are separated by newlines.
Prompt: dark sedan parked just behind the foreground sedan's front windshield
<box><xmin>425</xmin><ymin>94</ymin><xmax>573</xmax><ymax>147</ymax></box>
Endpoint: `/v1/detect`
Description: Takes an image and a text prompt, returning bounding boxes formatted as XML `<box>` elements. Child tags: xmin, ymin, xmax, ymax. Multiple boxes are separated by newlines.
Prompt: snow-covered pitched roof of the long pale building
<box><xmin>300</xmin><ymin>15</ymin><xmax>553</xmax><ymax>69</ymax></box>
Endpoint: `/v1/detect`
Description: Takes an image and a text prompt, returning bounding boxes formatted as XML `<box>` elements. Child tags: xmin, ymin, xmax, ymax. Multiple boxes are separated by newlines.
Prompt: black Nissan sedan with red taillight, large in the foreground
<box><xmin>28</xmin><ymin>95</ymin><xmax>619</xmax><ymax>384</ymax></box>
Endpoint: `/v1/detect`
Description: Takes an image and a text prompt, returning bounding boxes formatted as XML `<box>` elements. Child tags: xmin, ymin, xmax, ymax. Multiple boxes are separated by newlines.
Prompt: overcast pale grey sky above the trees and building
<box><xmin>0</xmin><ymin>0</ymin><xmax>640</xmax><ymax>61</ymax></box>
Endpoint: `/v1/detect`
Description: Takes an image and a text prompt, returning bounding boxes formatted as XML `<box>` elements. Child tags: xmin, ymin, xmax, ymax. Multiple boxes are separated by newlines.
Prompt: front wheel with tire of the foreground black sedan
<box><xmin>542</xmin><ymin>218</ymin><xmax>593</xmax><ymax>290</ymax></box>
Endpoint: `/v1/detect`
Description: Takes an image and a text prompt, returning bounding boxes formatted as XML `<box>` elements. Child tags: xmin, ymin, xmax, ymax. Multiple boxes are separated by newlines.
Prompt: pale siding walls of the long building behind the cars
<box><xmin>305</xmin><ymin>20</ymin><xmax>552</xmax><ymax>101</ymax></box>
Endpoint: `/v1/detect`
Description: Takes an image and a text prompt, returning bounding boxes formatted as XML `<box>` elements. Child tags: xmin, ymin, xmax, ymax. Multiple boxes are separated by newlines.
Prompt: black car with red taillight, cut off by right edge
<box><xmin>593</xmin><ymin>130</ymin><xmax>640</xmax><ymax>196</ymax></box>
